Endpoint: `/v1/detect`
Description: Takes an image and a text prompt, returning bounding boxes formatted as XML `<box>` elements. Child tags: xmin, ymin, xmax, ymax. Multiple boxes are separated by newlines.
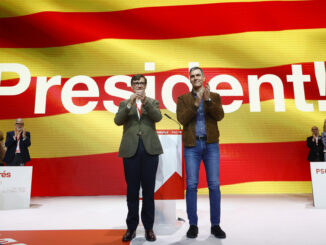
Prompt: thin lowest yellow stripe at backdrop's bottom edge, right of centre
<box><xmin>198</xmin><ymin>181</ymin><xmax>312</xmax><ymax>194</ymax></box>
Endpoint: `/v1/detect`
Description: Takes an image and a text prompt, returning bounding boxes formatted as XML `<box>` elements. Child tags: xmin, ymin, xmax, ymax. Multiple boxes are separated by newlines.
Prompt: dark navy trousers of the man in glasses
<box><xmin>123</xmin><ymin>138</ymin><xmax>158</xmax><ymax>230</ymax></box>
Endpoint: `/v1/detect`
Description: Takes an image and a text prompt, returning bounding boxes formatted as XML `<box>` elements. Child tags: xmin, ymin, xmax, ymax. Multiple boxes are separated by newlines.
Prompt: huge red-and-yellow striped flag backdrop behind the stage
<box><xmin>0</xmin><ymin>0</ymin><xmax>326</xmax><ymax>196</ymax></box>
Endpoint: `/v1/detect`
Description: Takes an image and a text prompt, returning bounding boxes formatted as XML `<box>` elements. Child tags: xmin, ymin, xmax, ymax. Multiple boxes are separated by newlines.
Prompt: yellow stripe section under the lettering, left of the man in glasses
<box><xmin>0</xmin><ymin>111</ymin><xmax>122</xmax><ymax>158</ymax></box>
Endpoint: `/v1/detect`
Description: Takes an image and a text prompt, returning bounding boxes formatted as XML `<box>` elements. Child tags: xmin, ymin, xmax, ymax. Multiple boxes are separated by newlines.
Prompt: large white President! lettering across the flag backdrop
<box><xmin>0</xmin><ymin>61</ymin><xmax>326</xmax><ymax>114</ymax></box>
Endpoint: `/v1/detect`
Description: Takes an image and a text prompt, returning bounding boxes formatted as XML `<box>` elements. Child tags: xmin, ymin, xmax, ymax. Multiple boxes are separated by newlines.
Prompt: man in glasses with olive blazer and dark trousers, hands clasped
<box><xmin>114</xmin><ymin>75</ymin><xmax>163</xmax><ymax>242</ymax></box>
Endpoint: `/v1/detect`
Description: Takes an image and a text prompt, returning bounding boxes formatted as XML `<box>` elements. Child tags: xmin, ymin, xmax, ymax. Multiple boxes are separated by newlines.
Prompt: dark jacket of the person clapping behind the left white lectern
<box><xmin>3</xmin><ymin>131</ymin><xmax>31</xmax><ymax>163</ymax></box>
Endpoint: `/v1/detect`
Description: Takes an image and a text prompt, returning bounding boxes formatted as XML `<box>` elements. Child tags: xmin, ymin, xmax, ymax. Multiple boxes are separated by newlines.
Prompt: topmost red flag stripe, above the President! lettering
<box><xmin>0</xmin><ymin>1</ymin><xmax>326</xmax><ymax>48</ymax></box>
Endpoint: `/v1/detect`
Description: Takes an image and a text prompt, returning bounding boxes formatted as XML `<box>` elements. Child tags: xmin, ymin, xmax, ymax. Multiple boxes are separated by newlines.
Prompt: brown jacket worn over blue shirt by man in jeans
<box><xmin>177</xmin><ymin>92</ymin><xmax>224</xmax><ymax>147</ymax></box>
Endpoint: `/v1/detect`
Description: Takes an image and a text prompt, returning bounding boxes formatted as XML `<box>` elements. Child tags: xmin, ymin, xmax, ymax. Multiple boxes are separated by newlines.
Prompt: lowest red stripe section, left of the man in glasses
<box><xmin>28</xmin><ymin>153</ymin><xmax>126</xmax><ymax>196</ymax></box>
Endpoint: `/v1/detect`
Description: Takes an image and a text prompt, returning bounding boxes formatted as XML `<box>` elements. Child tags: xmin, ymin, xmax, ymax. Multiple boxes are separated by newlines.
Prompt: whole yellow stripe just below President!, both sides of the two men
<box><xmin>0</xmin><ymin>100</ymin><xmax>325</xmax><ymax>158</ymax></box>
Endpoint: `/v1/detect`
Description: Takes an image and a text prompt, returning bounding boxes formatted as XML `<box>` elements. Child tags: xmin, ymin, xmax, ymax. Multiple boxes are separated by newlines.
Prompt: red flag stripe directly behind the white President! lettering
<box><xmin>0</xmin><ymin>63</ymin><xmax>325</xmax><ymax>119</ymax></box>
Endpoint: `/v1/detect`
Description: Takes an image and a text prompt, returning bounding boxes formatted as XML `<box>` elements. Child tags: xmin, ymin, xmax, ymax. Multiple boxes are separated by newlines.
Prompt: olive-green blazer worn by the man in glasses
<box><xmin>114</xmin><ymin>97</ymin><xmax>163</xmax><ymax>158</ymax></box>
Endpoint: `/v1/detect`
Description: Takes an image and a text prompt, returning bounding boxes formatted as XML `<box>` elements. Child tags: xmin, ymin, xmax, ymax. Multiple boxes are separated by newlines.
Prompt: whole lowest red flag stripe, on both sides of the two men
<box><xmin>15</xmin><ymin>141</ymin><xmax>310</xmax><ymax>196</ymax></box>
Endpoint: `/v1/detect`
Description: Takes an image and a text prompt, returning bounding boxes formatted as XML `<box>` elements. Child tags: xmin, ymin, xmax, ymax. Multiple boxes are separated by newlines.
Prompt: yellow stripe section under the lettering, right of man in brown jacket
<box><xmin>219</xmin><ymin>99</ymin><xmax>326</xmax><ymax>144</ymax></box>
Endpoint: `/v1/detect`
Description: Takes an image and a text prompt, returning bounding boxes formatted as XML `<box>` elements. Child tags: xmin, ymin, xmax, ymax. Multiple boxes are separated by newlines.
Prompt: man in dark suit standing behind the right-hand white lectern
<box><xmin>307</xmin><ymin>126</ymin><xmax>324</xmax><ymax>162</ymax></box>
